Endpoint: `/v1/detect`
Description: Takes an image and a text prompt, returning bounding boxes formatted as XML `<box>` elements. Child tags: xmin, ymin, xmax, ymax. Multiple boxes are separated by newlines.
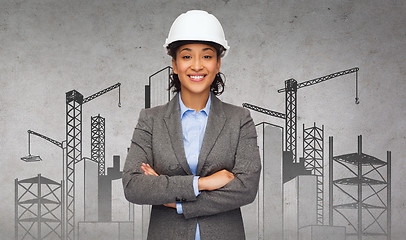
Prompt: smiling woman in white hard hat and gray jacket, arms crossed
<box><xmin>123</xmin><ymin>10</ymin><xmax>261</xmax><ymax>240</ymax></box>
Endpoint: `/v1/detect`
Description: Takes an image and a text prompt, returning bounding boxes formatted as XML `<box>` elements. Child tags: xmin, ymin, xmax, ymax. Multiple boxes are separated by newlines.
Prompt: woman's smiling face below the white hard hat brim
<box><xmin>172</xmin><ymin>43</ymin><xmax>221</xmax><ymax>96</ymax></box>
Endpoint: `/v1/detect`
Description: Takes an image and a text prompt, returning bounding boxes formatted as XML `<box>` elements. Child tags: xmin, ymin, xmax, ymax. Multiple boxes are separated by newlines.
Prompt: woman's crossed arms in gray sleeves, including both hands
<box><xmin>123</xmin><ymin>110</ymin><xmax>261</xmax><ymax>219</ymax></box>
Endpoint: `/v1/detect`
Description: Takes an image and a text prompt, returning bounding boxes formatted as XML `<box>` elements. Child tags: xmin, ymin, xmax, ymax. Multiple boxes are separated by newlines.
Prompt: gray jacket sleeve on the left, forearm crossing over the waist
<box><xmin>122</xmin><ymin>109</ymin><xmax>196</xmax><ymax>205</ymax></box>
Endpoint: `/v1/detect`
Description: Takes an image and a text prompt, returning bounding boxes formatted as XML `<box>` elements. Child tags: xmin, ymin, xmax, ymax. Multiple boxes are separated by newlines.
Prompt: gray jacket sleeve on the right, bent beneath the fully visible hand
<box><xmin>182</xmin><ymin>110</ymin><xmax>261</xmax><ymax>219</ymax></box>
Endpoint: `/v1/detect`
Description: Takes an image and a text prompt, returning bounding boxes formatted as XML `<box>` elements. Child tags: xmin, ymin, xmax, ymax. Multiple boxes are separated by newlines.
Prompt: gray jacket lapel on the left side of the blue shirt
<box><xmin>164</xmin><ymin>93</ymin><xmax>193</xmax><ymax>175</ymax></box>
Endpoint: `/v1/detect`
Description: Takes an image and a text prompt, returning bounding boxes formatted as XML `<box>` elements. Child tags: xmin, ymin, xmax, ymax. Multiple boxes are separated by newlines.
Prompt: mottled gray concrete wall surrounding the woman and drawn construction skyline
<box><xmin>0</xmin><ymin>0</ymin><xmax>406</xmax><ymax>239</ymax></box>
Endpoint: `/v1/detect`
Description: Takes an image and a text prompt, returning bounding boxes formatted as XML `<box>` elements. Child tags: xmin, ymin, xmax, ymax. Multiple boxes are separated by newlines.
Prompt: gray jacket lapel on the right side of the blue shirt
<box><xmin>196</xmin><ymin>95</ymin><xmax>226</xmax><ymax>176</ymax></box>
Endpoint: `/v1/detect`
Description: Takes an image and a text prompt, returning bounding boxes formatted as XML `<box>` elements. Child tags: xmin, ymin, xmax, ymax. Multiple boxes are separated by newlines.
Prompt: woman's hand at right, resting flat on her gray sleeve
<box><xmin>198</xmin><ymin>169</ymin><xmax>234</xmax><ymax>191</ymax></box>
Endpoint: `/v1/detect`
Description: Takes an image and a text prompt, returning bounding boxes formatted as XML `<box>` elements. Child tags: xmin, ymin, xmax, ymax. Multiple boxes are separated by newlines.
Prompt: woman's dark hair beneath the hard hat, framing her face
<box><xmin>167</xmin><ymin>41</ymin><xmax>226</xmax><ymax>95</ymax></box>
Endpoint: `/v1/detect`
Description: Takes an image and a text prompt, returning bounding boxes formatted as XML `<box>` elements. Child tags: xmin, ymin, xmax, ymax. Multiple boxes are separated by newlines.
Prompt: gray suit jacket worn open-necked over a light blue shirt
<box><xmin>123</xmin><ymin>95</ymin><xmax>261</xmax><ymax>240</ymax></box>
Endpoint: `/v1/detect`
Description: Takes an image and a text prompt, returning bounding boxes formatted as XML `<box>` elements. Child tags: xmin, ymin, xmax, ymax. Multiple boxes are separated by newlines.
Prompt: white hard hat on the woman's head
<box><xmin>164</xmin><ymin>10</ymin><xmax>230</xmax><ymax>57</ymax></box>
